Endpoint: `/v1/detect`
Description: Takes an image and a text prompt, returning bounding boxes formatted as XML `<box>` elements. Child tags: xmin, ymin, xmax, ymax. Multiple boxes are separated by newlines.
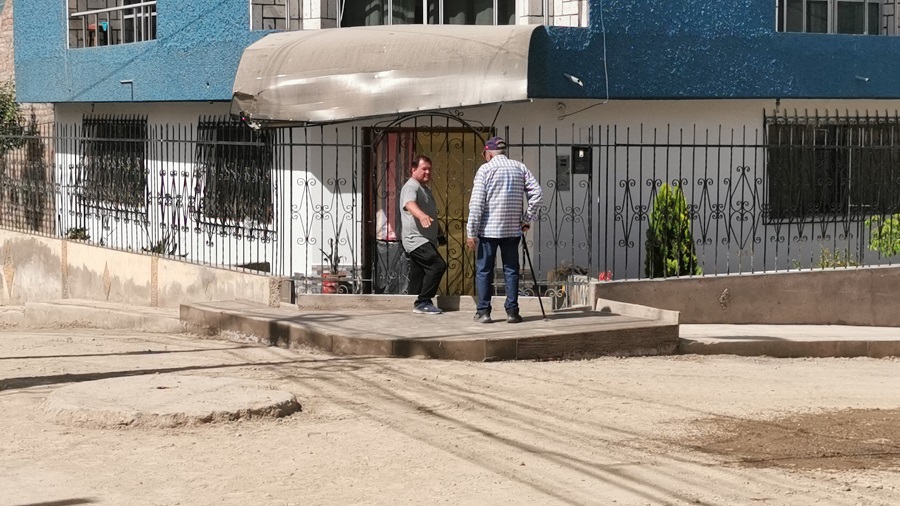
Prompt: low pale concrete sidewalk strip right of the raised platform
<box><xmin>678</xmin><ymin>324</ymin><xmax>900</xmax><ymax>358</ymax></box>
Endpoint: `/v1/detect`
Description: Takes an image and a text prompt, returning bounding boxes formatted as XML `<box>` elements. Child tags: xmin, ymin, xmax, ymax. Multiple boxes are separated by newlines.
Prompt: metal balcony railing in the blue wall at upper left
<box><xmin>69</xmin><ymin>0</ymin><xmax>156</xmax><ymax>48</ymax></box>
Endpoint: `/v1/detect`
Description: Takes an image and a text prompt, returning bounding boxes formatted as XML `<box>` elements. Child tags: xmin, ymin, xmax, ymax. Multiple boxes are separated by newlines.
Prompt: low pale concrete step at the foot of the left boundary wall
<box><xmin>14</xmin><ymin>299</ymin><xmax>184</xmax><ymax>333</ymax></box>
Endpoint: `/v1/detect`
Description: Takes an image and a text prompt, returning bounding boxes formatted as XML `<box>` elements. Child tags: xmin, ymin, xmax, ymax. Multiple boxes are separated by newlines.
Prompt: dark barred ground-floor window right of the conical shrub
<box><xmin>766</xmin><ymin>118</ymin><xmax>900</xmax><ymax>220</ymax></box>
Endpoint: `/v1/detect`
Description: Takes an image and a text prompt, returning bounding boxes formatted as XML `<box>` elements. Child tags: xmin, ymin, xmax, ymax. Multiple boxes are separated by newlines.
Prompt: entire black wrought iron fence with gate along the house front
<box><xmin>0</xmin><ymin>114</ymin><xmax>900</xmax><ymax>306</ymax></box>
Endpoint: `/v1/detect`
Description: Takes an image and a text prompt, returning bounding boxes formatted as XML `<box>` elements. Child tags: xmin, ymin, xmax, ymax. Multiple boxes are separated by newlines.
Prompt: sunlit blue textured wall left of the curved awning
<box><xmin>13</xmin><ymin>0</ymin><xmax>268</xmax><ymax>102</ymax></box>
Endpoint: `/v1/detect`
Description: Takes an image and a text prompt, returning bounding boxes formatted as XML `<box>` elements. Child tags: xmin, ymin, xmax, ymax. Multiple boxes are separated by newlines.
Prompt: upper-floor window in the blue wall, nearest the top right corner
<box><xmin>777</xmin><ymin>0</ymin><xmax>897</xmax><ymax>35</ymax></box>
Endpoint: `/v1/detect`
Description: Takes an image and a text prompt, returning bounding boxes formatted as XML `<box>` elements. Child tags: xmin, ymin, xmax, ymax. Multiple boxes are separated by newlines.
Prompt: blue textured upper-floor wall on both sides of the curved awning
<box><xmin>14</xmin><ymin>0</ymin><xmax>900</xmax><ymax>102</ymax></box>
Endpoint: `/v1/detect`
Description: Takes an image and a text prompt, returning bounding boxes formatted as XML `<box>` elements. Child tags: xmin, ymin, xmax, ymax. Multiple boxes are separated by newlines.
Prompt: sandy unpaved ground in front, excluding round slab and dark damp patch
<box><xmin>0</xmin><ymin>329</ymin><xmax>900</xmax><ymax>506</ymax></box>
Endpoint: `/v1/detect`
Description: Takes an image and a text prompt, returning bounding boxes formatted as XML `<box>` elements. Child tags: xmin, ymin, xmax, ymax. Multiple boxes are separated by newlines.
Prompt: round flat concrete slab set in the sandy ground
<box><xmin>43</xmin><ymin>374</ymin><xmax>300</xmax><ymax>428</ymax></box>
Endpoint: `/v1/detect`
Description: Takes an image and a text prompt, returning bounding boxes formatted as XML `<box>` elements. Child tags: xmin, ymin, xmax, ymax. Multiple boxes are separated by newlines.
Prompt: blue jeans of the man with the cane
<box><xmin>475</xmin><ymin>237</ymin><xmax>521</xmax><ymax>313</ymax></box>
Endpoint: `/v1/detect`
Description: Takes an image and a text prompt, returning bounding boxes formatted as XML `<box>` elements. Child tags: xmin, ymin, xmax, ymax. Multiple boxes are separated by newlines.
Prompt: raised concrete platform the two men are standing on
<box><xmin>181</xmin><ymin>296</ymin><xmax>678</xmax><ymax>361</ymax></box>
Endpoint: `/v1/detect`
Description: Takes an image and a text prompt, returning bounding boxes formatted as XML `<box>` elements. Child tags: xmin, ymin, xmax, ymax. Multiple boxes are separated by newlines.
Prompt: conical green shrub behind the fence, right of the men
<box><xmin>644</xmin><ymin>184</ymin><xmax>703</xmax><ymax>278</ymax></box>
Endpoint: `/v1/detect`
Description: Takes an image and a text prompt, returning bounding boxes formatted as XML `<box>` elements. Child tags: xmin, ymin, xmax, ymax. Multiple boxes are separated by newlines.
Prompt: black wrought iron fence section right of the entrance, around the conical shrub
<box><xmin>598</xmin><ymin>113</ymin><xmax>900</xmax><ymax>279</ymax></box>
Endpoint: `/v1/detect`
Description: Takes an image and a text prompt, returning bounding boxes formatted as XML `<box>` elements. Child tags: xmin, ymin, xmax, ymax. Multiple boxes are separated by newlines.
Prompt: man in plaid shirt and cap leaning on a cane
<box><xmin>466</xmin><ymin>137</ymin><xmax>543</xmax><ymax>323</ymax></box>
